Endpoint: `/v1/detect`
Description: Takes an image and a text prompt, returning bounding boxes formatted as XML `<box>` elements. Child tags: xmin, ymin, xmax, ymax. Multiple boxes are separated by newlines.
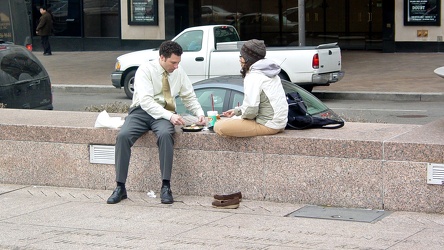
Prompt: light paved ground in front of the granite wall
<box><xmin>0</xmin><ymin>184</ymin><xmax>444</xmax><ymax>250</ymax></box>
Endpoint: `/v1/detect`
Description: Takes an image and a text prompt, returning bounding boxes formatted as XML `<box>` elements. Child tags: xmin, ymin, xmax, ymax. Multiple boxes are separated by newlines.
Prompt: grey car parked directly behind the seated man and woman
<box><xmin>176</xmin><ymin>76</ymin><xmax>342</xmax><ymax>121</ymax></box>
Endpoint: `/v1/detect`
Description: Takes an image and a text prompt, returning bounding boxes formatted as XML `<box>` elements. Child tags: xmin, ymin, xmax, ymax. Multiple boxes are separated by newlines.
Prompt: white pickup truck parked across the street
<box><xmin>111</xmin><ymin>25</ymin><xmax>344</xmax><ymax>98</ymax></box>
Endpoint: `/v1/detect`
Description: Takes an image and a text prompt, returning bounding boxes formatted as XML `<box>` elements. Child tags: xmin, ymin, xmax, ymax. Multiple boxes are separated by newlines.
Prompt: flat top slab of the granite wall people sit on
<box><xmin>0</xmin><ymin>109</ymin><xmax>430</xmax><ymax>159</ymax></box>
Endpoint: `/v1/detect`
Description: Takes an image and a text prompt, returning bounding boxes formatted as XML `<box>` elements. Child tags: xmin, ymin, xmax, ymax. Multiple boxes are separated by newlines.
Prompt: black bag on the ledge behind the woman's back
<box><xmin>286</xmin><ymin>92</ymin><xmax>344</xmax><ymax>129</ymax></box>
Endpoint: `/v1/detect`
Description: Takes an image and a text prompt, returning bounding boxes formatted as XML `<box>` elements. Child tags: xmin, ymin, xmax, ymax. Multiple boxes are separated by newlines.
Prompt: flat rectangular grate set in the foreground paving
<box><xmin>286</xmin><ymin>206</ymin><xmax>390</xmax><ymax>223</ymax></box>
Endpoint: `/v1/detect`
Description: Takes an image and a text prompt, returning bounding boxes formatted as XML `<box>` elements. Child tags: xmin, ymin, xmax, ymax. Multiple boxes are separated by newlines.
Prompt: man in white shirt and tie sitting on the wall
<box><xmin>107</xmin><ymin>41</ymin><xmax>205</xmax><ymax>204</ymax></box>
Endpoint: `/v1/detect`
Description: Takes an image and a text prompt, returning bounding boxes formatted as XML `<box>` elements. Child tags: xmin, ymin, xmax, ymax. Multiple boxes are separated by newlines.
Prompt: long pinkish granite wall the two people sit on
<box><xmin>0</xmin><ymin>109</ymin><xmax>444</xmax><ymax>213</ymax></box>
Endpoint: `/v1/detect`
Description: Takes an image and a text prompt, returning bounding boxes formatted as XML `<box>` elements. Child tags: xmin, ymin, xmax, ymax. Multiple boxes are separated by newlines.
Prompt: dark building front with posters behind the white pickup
<box><xmin>29</xmin><ymin>0</ymin><xmax>444</xmax><ymax>52</ymax></box>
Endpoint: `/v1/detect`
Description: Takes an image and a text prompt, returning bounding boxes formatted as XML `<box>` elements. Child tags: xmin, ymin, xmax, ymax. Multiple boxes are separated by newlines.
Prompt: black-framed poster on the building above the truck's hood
<box><xmin>128</xmin><ymin>0</ymin><xmax>159</xmax><ymax>25</ymax></box>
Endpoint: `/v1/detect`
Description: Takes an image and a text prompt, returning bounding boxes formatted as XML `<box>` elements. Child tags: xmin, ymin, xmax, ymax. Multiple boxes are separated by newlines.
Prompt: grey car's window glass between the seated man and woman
<box><xmin>176</xmin><ymin>88</ymin><xmax>230</xmax><ymax>114</ymax></box>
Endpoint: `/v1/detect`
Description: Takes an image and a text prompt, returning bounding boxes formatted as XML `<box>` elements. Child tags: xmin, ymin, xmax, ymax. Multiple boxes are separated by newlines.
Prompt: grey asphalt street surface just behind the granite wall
<box><xmin>53</xmin><ymin>89</ymin><xmax>444</xmax><ymax>125</ymax></box>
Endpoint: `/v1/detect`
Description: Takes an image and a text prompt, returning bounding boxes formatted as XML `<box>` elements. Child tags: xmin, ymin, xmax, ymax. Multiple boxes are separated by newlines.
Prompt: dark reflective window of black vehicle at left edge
<box><xmin>0</xmin><ymin>49</ymin><xmax>45</xmax><ymax>85</ymax></box>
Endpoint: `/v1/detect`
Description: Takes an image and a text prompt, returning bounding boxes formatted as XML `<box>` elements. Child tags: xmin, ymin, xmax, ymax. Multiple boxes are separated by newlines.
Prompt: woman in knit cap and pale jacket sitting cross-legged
<box><xmin>214</xmin><ymin>39</ymin><xmax>288</xmax><ymax>137</ymax></box>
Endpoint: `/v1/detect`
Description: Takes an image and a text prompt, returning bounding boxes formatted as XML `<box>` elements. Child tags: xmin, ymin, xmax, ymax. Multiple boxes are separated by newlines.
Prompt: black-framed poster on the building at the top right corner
<box><xmin>404</xmin><ymin>0</ymin><xmax>441</xmax><ymax>26</ymax></box>
